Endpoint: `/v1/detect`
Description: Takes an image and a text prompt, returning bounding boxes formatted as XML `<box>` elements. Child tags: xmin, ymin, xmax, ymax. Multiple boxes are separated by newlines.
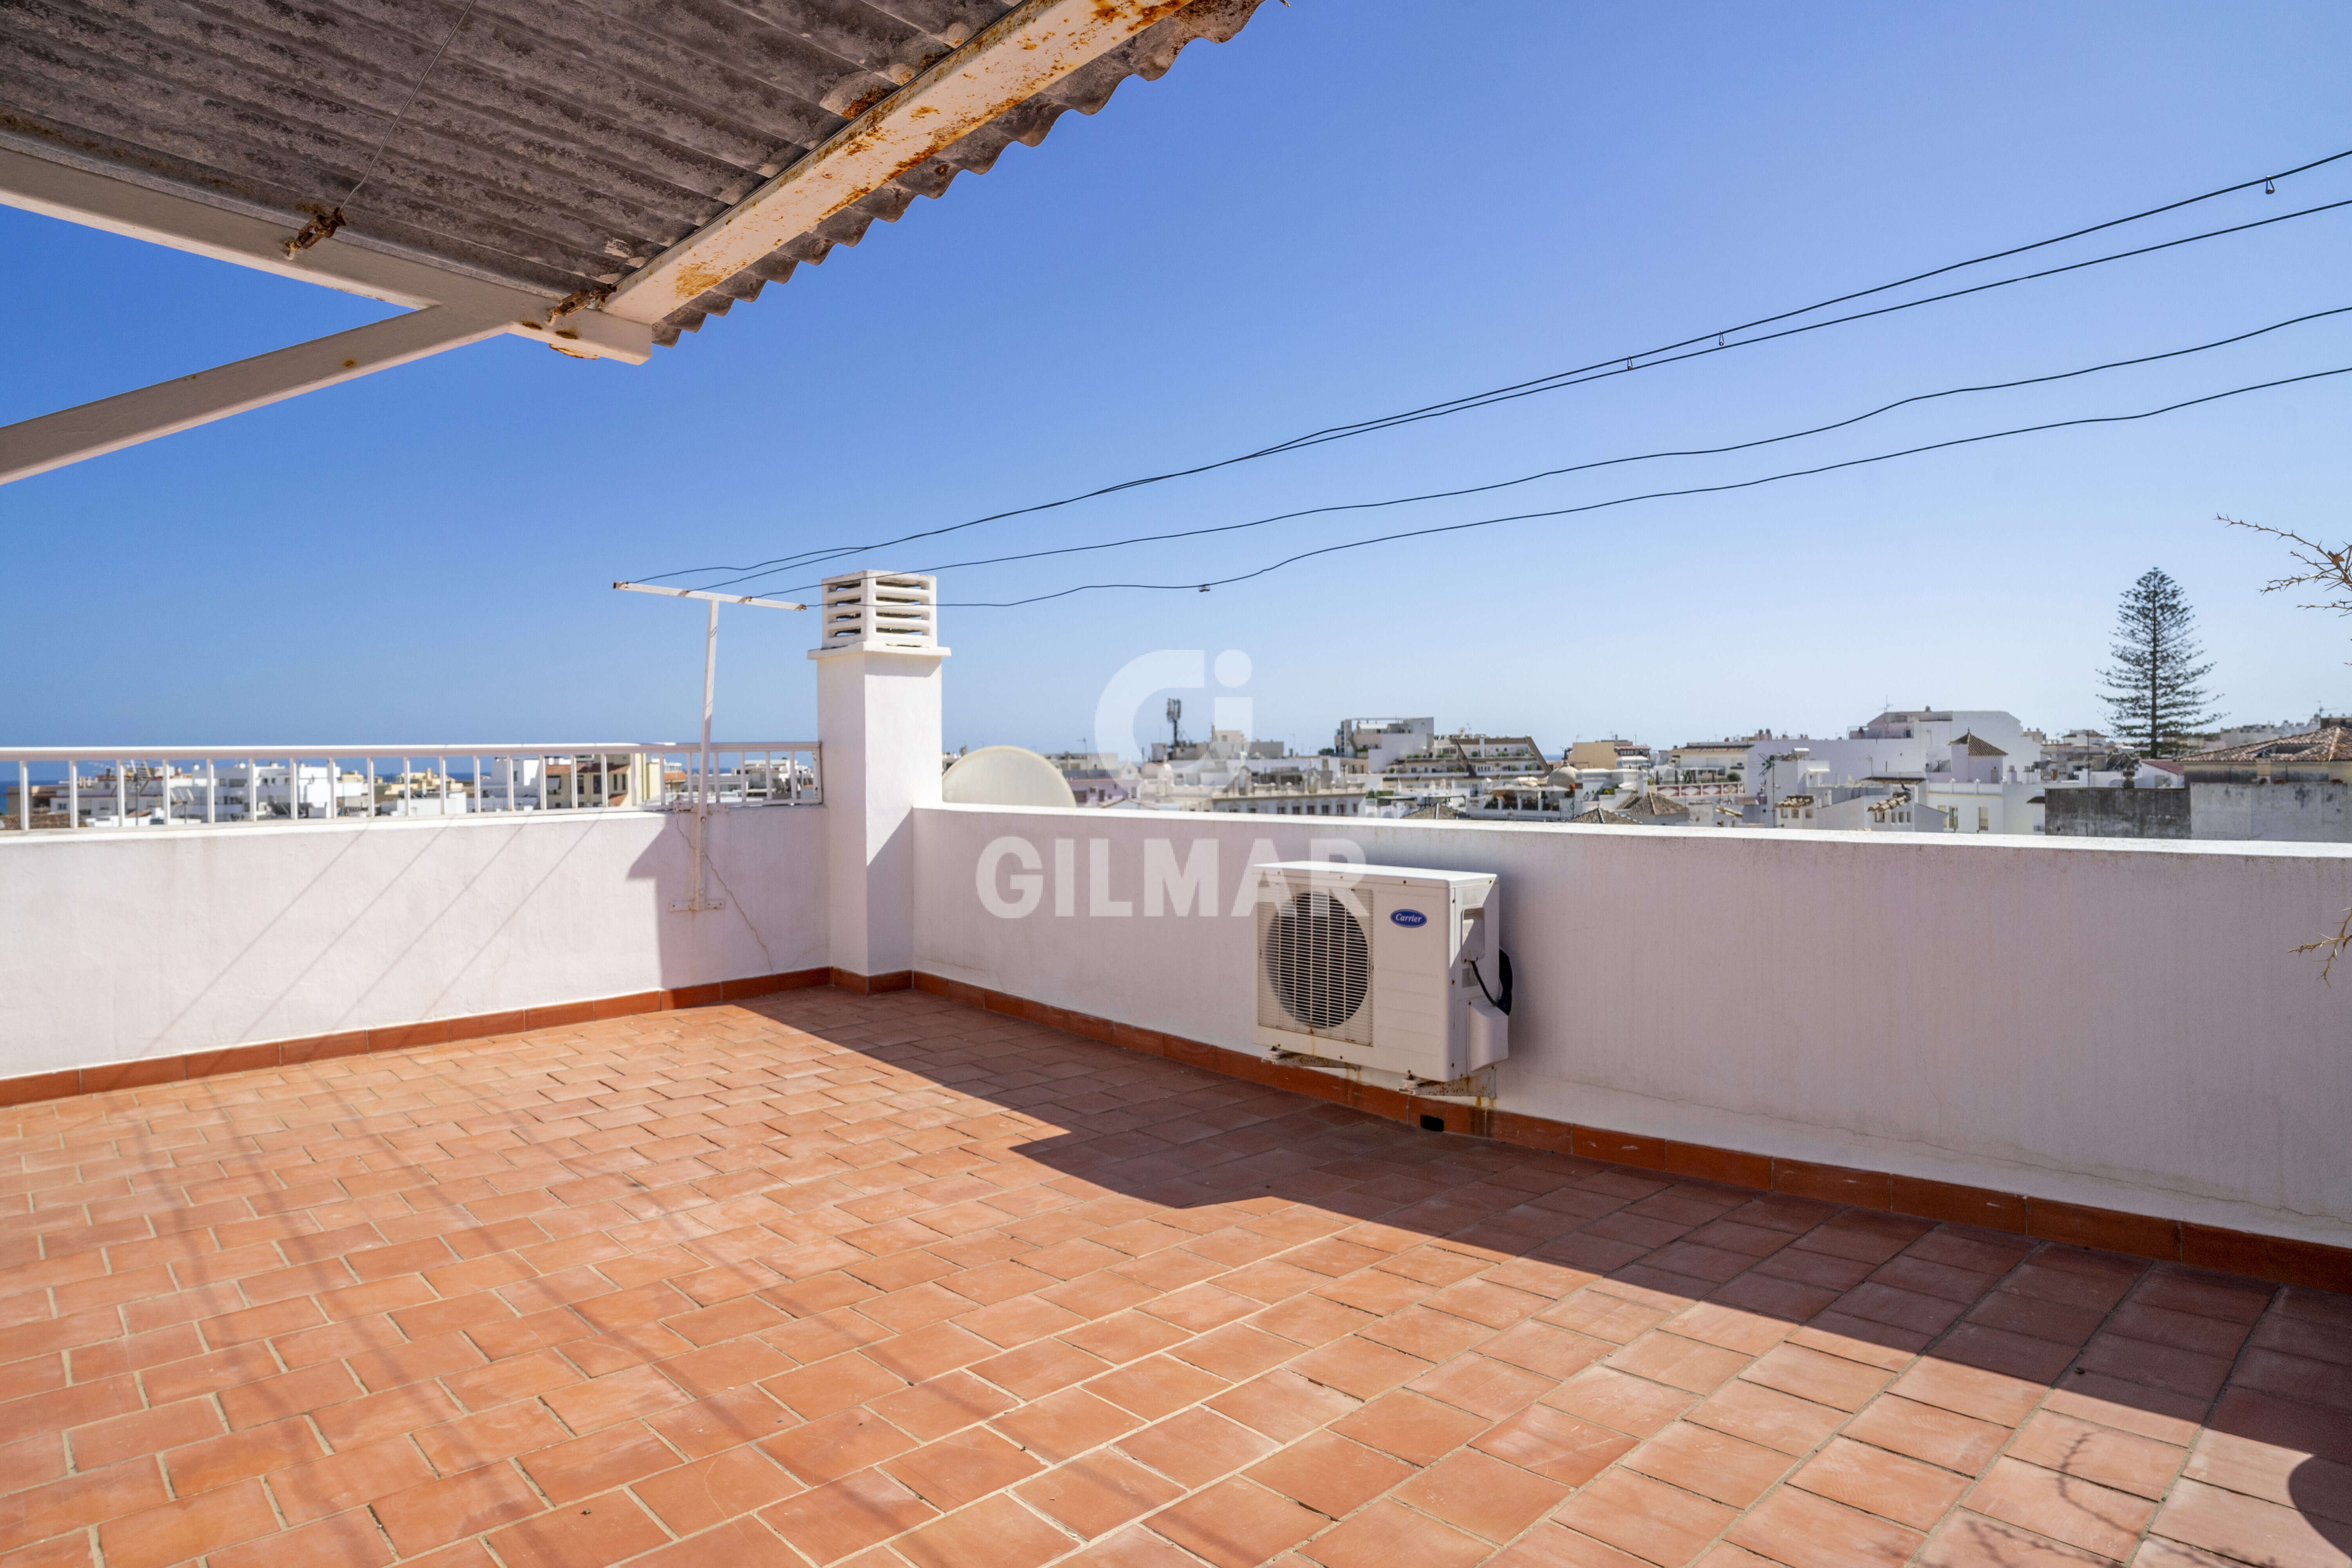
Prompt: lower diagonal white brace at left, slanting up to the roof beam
<box><xmin>0</xmin><ymin>306</ymin><xmax>510</xmax><ymax>484</ymax></box>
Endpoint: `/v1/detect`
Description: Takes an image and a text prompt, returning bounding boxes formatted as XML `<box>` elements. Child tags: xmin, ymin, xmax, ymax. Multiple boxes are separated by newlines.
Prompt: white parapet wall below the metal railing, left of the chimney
<box><xmin>0</xmin><ymin>806</ymin><xmax>826</xmax><ymax>1077</ymax></box>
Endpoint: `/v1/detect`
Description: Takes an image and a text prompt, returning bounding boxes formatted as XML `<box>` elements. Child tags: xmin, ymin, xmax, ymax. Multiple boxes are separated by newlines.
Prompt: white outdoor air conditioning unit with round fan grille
<box><xmin>1256</xmin><ymin>860</ymin><xmax>1510</xmax><ymax>1084</ymax></box>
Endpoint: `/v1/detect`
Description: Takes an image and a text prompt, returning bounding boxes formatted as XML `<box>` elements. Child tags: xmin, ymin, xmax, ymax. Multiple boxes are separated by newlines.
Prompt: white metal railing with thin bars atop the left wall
<box><xmin>0</xmin><ymin>740</ymin><xmax>823</xmax><ymax>832</ymax></box>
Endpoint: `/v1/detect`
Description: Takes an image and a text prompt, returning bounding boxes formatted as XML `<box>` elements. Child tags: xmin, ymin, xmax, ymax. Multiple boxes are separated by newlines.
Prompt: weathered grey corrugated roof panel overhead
<box><xmin>0</xmin><ymin>0</ymin><xmax>1258</xmax><ymax>343</ymax></box>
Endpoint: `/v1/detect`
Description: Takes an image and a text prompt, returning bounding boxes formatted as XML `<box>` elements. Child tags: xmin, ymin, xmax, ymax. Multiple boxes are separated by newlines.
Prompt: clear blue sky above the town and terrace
<box><xmin>0</xmin><ymin>0</ymin><xmax>2352</xmax><ymax>750</ymax></box>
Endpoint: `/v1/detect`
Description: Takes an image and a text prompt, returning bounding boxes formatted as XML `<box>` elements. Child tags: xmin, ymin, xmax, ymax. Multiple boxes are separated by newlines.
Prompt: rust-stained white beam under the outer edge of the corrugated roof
<box><xmin>604</xmin><ymin>0</ymin><xmax>1190</xmax><ymax>325</ymax></box>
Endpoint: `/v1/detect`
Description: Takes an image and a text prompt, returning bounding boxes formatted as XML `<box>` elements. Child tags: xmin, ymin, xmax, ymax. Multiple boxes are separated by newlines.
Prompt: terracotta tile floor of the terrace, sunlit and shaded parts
<box><xmin>0</xmin><ymin>992</ymin><xmax>2352</xmax><ymax>1568</ymax></box>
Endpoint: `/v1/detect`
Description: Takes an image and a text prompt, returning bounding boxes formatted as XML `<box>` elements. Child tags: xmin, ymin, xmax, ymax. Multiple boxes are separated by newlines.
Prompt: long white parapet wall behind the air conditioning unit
<box><xmin>915</xmin><ymin>806</ymin><xmax>2352</xmax><ymax>1246</ymax></box>
